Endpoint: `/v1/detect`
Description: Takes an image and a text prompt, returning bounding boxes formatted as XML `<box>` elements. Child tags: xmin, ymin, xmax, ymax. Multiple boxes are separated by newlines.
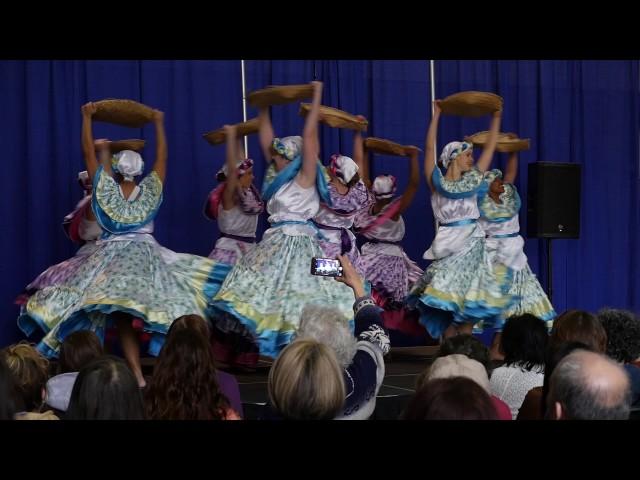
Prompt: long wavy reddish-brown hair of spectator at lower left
<box><xmin>145</xmin><ymin>328</ymin><xmax>229</xmax><ymax>420</ymax></box>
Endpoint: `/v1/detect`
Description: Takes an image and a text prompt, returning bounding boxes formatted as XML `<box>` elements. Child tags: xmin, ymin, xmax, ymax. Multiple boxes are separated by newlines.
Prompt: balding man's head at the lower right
<box><xmin>547</xmin><ymin>350</ymin><xmax>631</xmax><ymax>420</ymax></box>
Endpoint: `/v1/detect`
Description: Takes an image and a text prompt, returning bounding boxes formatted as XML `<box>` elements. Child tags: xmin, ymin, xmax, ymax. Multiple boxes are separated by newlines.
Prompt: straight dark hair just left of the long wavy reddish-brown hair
<box><xmin>65</xmin><ymin>355</ymin><xmax>144</xmax><ymax>420</ymax></box>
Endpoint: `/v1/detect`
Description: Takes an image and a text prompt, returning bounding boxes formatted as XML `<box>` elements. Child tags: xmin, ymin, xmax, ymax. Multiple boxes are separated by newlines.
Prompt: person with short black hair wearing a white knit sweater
<box><xmin>490</xmin><ymin>313</ymin><xmax>548</xmax><ymax>419</ymax></box>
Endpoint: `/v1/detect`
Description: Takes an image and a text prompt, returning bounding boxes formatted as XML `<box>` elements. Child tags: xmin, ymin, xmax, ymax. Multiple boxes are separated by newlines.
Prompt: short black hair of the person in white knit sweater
<box><xmin>500</xmin><ymin>313</ymin><xmax>548</xmax><ymax>371</ymax></box>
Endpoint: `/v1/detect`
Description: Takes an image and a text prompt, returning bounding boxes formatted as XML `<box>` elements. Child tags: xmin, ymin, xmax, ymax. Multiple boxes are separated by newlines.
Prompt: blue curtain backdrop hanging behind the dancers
<box><xmin>0</xmin><ymin>60</ymin><xmax>640</xmax><ymax>346</ymax></box>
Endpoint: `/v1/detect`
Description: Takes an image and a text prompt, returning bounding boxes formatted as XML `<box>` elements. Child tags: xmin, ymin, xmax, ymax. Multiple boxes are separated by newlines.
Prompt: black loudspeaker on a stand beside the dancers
<box><xmin>527</xmin><ymin>162</ymin><xmax>580</xmax><ymax>238</ymax></box>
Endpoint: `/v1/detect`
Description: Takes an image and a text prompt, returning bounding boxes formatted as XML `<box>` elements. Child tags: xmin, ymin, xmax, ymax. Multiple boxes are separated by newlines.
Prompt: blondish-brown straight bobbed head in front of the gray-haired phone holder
<box><xmin>269</xmin><ymin>339</ymin><xmax>345</xmax><ymax>420</ymax></box>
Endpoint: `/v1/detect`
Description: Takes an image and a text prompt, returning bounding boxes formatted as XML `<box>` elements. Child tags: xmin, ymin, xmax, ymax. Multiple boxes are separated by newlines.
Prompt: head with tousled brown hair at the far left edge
<box><xmin>2</xmin><ymin>342</ymin><xmax>49</xmax><ymax>411</ymax></box>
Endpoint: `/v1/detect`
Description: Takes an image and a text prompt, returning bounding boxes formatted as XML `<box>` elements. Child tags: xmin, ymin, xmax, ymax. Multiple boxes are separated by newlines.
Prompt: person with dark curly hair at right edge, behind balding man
<box><xmin>598</xmin><ymin>309</ymin><xmax>640</xmax><ymax>407</ymax></box>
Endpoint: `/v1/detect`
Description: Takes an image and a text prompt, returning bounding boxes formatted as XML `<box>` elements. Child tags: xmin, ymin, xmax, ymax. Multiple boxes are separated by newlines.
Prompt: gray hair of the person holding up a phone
<box><xmin>296</xmin><ymin>304</ymin><xmax>358</xmax><ymax>368</ymax></box>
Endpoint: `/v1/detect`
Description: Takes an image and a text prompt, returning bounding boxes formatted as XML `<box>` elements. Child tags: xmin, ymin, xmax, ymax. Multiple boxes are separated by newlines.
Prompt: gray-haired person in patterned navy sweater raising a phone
<box><xmin>267</xmin><ymin>256</ymin><xmax>390</xmax><ymax>420</ymax></box>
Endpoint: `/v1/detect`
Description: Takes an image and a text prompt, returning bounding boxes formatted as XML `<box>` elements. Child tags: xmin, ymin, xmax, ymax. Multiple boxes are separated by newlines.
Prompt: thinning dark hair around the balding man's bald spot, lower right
<box><xmin>546</xmin><ymin>352</ymin><xmax>631</xmax><ymax>420</ymax></box>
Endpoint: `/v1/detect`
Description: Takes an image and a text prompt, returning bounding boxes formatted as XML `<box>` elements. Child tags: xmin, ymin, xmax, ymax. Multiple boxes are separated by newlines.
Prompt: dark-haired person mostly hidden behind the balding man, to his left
<box><xmin>516</xmin><ymin>342</ymin><xmax>592</xmax><ymax>420</ymax></box>
